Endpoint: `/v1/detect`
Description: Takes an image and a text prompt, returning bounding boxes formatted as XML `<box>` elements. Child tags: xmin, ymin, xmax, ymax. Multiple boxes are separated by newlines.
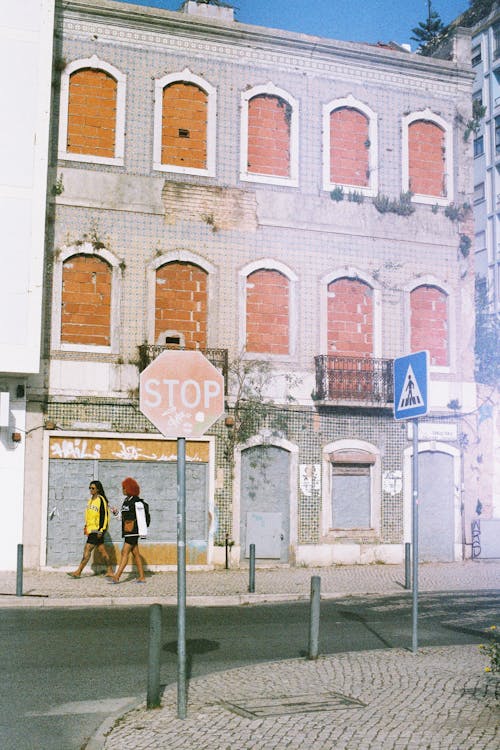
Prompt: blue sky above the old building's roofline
<box><xmin>117</xmin><ymin>0</ymin><xmax>469</xmax><ymax>49</ymax></box>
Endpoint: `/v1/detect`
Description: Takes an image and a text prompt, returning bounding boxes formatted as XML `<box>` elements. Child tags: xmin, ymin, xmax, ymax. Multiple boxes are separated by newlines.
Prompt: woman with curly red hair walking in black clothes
<box><xmin>110</xmin><ymin>477</ymin><xmax>150</xmax><ymax>583</ymax></box>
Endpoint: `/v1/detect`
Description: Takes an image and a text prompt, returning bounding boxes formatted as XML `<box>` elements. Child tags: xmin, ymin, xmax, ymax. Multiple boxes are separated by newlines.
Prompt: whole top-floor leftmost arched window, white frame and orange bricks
<box><xmin>59</xmin><ymin>56</ymin><xmax>125</xmax><ymax>165</ymax></box>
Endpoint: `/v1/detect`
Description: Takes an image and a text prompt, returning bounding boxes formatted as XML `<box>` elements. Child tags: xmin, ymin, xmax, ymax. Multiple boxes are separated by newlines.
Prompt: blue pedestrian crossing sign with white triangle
<box><xmin>394</xmin><ymin>351</ymin><xmax>429</xmax><ymax>419</ymax></box>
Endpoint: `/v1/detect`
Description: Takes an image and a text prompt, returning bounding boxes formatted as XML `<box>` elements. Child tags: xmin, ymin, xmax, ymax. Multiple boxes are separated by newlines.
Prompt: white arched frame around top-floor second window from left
<box><xmin>153</xmin><ymin>68</ymin><xmax>217</xmax><ymax>177</ymax></box>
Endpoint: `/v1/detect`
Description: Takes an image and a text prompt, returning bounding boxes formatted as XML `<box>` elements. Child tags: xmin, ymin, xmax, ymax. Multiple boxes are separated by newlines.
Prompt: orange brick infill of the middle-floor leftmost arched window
<box><xmin>61</xmin><ymin>255</ymin><xmax>112</xmax><ymax>346</ymax></box>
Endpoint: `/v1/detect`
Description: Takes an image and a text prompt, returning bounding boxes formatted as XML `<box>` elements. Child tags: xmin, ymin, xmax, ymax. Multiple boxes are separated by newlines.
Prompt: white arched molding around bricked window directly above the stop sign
<box><xmin>146</xmin><ymin>249</ymin><xmax>217</xmax><ymax>347</ymax></box>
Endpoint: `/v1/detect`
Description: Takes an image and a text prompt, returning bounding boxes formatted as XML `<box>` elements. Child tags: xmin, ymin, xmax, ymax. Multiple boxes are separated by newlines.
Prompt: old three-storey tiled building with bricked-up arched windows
<box><xmin>26</xmin><ymin>0</ymin><xmax>476</xmax><ymax>566</ymax></box>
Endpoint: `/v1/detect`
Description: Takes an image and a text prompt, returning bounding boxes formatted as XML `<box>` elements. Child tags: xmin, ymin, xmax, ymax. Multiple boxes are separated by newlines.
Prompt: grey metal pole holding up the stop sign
<box><xmin>177</xmin><ymin>437</ymin><xmax>186</xmax><ymax>719</ymax></box>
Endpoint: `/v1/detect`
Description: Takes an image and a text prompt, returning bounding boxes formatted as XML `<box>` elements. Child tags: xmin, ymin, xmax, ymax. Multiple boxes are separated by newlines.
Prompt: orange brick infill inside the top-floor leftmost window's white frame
<box><xmin>66</xmin><ymin>68</ymin><xmax>117</xmax><ymax>158</ymax></box>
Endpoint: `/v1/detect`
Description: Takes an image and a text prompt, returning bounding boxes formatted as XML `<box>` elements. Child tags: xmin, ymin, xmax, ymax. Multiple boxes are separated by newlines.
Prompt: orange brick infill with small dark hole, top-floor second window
<box><xmin>161</xmin><ymin>81</ymin><xmax>208</xmax><ymax>169</ymax></box>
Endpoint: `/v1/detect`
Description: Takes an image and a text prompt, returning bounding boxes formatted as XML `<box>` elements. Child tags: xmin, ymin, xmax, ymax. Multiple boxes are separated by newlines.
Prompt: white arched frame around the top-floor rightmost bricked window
<box><xmin>401</xmin><ymin>109</ymin><xmax>455</xmax><ymax>206</ymax></box>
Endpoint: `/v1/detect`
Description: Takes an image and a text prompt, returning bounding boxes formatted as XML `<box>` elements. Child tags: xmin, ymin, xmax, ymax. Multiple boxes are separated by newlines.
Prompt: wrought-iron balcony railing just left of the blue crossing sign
<box><xmin>314</xmin><ymin>354</ymin><xmax>394</xmax><ymax>406</ymax></box>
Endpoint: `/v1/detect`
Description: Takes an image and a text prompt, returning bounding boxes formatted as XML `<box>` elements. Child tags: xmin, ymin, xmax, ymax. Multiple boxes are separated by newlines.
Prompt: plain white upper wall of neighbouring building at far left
<box><xmin>0</xmin><ymin>0</ymin><xmax>54</xmax><ymax>373</ymax></box>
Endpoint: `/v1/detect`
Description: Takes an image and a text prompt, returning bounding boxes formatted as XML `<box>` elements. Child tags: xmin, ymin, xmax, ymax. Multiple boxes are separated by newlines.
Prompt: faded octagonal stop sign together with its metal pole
<box><xmin>139</xmin><ymin>350</ymin><xmax>224</xmax><ymax>719</ymax></box>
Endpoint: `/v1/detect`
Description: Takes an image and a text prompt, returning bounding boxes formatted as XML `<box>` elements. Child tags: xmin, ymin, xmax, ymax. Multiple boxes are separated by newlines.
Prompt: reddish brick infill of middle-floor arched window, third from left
<box><xmin>246</xmin><ymin>269</ymin><xmax>290</xmax><ymax>354</ymax></box>
